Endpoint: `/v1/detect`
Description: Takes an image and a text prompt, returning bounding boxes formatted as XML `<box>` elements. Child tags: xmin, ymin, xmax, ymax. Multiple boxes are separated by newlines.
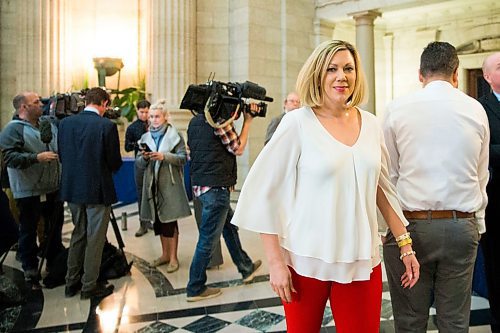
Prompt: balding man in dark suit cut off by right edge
<box><xmin>479</xmin><ymin>52</ymin><xmax>500</xmax><ymax>333</ymax></box>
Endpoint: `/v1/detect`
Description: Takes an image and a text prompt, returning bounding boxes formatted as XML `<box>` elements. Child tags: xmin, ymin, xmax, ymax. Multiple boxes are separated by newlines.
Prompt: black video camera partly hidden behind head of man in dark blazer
<box><xmin>41</xmin><ymin>89</ymin><xmax>121</xmax><ymax>119</ymax></box>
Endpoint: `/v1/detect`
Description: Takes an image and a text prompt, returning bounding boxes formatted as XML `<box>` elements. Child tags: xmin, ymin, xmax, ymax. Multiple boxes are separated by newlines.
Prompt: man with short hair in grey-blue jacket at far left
<box><xmin>0</xmin><ymin>92</ymin><xmax>64</xmax><ymax>288</ymax></box>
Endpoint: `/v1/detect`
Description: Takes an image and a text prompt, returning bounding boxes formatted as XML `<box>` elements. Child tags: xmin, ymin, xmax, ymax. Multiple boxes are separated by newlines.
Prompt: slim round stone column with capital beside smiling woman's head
<box><xmin>350</xmin><ymin>10</ymin><xmax>380</xmax><ymax>113</ymax></box>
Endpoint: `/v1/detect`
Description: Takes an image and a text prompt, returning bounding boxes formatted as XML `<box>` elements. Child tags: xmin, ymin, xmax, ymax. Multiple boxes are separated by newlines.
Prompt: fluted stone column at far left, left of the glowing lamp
<box><xmin>16</xmin><ymin>0</ymin><xmax>71</xmax><ymax>96</ymax></box>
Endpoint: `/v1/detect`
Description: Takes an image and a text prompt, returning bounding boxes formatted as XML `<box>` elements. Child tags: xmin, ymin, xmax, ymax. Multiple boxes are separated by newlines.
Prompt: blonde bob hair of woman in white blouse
<box><xmin>296</xmin><ymin>40</ymin><xmax>368</xmax><ymax>107</ymax></box>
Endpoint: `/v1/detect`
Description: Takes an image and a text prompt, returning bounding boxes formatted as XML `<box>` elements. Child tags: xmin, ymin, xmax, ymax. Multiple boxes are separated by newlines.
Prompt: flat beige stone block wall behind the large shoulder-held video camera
<box><xmin>196</xmin><ymin>0</ymin><xmax>314</xmax><ymax>182</ymax></box>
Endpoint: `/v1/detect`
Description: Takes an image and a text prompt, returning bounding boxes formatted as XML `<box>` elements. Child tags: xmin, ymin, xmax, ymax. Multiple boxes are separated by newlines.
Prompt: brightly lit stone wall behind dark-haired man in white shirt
<box><xmin>375</xmin><ymin>3</ymin><xmax>500</xmax><ymax>115</ymax></box>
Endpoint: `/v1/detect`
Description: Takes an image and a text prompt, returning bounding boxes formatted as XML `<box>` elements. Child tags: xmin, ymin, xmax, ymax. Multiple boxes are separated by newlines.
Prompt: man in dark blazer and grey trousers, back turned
<box><xmin>58</xmin><ymin>88</ymin><xmax>122</xmax><ymax>299</ymax></box>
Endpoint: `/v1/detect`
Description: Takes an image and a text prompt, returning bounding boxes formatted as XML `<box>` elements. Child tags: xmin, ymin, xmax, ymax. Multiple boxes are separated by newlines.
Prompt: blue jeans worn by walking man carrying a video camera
<box><xmin>186</xmin><ymin>187</ymin><xmax>253</xmax><ymax>297</ymax></box>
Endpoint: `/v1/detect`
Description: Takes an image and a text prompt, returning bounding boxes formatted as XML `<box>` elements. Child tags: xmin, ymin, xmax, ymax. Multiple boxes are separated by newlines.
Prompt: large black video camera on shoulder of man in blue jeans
<box><xmin>180</xmin><ymin>77</ymin><xmax>273</xmax><ymax>128</ymax></box>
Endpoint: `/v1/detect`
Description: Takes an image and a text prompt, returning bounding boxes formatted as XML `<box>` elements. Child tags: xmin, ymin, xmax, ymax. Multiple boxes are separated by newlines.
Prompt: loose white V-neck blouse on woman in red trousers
<box><xmin>231</xmin><ymin>107</ymin><xmax>408</xmax><ymax>283</ymax></box>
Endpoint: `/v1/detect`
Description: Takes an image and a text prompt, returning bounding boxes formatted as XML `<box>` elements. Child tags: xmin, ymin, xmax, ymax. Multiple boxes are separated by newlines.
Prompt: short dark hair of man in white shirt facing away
<box><xmin>420</xmin><ymin>42</ymin><xmax>459</xmax><ymax>77</ymax></box>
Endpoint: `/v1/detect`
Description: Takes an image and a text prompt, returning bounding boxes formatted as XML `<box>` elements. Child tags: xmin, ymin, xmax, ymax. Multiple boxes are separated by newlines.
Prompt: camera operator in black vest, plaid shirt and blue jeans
<box><xmin>186</xmin><ymin>104</ymin><xmax>262</xmax><ymax>302</ymax></box>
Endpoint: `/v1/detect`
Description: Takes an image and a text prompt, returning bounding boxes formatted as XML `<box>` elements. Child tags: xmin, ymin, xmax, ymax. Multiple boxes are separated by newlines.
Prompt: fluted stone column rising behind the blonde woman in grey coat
<box><xmin>146</xmin><ymin>0</ymin><xmax>196</xmax><ymax>130</ymax></box>
